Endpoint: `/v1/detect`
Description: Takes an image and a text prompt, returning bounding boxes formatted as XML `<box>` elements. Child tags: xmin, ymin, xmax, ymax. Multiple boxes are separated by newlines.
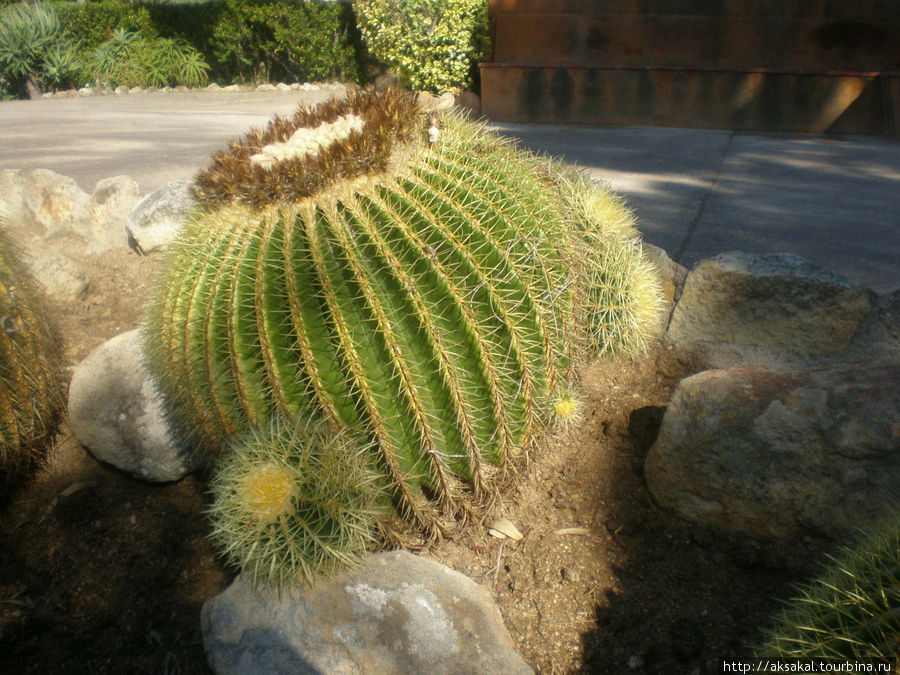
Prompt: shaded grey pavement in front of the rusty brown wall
<box><xmin>498</xmin><ymin>124</ymin><xmax>900</xmax><ymax>292</ymax></box>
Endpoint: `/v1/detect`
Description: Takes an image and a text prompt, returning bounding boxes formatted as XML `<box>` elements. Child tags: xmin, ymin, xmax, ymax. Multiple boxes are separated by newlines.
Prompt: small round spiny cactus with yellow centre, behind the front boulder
<box><xmin>211</xmin><ymin>420</ymin><xmax>379</xmax><ymax>586</ymax></box>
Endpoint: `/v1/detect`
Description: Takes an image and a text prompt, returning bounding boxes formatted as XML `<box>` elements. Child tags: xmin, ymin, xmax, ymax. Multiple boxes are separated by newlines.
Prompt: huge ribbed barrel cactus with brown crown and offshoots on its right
<box><xmin>145</xmin><ymin>90</ymin><xmax>660</xmax><ymax>588</ymax></box>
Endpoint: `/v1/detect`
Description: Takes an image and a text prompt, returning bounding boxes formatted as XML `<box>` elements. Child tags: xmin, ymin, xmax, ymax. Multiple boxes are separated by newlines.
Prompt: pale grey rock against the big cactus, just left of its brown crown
<box><xmin>125</xmin><ymin>180</ymin><xmax>194</xmax><ymax>255</ymax></box>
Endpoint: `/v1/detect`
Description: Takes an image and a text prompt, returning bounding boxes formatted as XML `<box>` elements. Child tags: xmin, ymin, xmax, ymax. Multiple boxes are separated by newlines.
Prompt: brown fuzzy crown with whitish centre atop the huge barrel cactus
<box><xmin>194</xmin><ymin>91</ymin><xmax>425</xmax><ymax>207</ymax></box>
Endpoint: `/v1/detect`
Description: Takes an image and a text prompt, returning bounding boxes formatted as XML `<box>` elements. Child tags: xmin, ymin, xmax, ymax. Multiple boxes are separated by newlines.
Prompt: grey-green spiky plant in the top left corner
<box><xmin>0</xmin><ymin>3</ymin><xmax>81</xmax><ymax>98</ymax></box>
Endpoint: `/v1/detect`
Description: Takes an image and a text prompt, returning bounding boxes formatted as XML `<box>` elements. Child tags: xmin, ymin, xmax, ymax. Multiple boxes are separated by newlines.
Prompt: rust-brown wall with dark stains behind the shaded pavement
<box><xmin>481</xmin><ymin>0</ymin><xmax>900</xmax><ymax>134</ymax></box>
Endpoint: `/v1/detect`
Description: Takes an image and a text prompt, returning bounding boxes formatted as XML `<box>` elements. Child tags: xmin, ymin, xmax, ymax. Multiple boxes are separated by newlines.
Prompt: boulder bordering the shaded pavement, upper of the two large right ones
<box><xmin>667</xmin><ymin>252</ymin><xmax>874</xmax><ymax>368</ymax></box>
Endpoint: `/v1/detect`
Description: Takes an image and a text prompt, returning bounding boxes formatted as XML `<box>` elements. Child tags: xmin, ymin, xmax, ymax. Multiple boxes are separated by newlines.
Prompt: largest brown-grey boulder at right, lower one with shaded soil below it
<box><xmin>645</xmin><ymin>362</ymin><xmax>900</xmax><ymax>538</ymax></box>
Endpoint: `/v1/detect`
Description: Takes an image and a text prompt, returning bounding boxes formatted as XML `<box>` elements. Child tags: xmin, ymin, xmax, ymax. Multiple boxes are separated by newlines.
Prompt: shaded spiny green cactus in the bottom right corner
<box><xmin>758</xmin><ymin>513</ymin><xmax>900</xmax><ymax>666</ymax></box>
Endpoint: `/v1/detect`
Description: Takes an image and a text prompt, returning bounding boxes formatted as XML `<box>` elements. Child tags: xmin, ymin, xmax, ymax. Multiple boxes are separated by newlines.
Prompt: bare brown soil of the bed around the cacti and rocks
<box><xmin>0</xmin><ymin>242</ymin><xmax>829</xmax><ymax>675</ymax></box>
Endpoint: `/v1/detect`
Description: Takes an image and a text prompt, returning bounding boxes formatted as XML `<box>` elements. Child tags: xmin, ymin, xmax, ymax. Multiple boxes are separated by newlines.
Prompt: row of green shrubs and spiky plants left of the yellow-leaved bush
<box><xmin>0</xmin><ymin>0</ymin><xmax>360</xmax><ymax>98</ymax></box>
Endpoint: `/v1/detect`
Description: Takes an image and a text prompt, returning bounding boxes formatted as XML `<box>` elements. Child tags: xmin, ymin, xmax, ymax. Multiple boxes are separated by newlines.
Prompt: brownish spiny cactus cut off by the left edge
<box><xmin>0</xmin><ymin>231</ymin><xmax>64</xmax><ymax>494</ymax></box>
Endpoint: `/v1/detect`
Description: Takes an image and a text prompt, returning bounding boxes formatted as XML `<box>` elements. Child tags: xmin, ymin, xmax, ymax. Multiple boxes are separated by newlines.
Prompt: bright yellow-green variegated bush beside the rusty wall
<box><xmin>353</xmin><ymin>0</ymin><xmax>489</xmax><ymax>92</ymax></box>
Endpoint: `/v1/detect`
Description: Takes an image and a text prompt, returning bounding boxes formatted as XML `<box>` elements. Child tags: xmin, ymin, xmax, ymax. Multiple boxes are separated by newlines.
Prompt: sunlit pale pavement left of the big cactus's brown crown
<box><xmin>0</xmin><ymin>90</ymin><xmax>332</xmax><ymax>192</ymax></box>
